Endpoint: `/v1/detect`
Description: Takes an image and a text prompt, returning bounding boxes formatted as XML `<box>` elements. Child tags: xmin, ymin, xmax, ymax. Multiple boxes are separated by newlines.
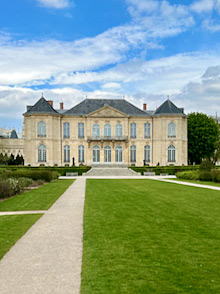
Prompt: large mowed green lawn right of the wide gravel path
<box><xmin>81</xmin><ymin>180</ymin><xmax>220</xmax><ymax>294</ymax></box>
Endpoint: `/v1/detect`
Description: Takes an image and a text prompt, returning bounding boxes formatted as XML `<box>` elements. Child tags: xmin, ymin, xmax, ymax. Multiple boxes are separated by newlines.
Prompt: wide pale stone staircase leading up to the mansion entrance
<box><xmin>84</xmin><ymin>164</ymin><xmax>139</xmax><ymax>177</ymax></box>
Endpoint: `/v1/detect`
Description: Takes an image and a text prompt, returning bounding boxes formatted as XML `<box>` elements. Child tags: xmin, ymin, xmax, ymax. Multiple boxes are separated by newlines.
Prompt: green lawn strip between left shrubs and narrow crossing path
<box><xmin>0</xmin><ymin>180</ymin><xmax>74</xmax><ymax>211</ymax></box>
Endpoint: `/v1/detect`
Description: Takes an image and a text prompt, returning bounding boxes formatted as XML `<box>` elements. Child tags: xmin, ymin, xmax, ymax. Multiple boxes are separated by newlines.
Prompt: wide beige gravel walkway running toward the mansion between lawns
<box><xmin>0</xmin><ymin>178</ymin><xmax>86</xmax><ymax>294</ymax></box>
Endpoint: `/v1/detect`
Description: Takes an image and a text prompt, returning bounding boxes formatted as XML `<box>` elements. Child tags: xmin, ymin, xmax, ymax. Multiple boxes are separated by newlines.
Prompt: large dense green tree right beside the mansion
<box><xmin>188</xmin><ymin>112</ymin><xmax>219</xmax><ymax>164</ymax></box>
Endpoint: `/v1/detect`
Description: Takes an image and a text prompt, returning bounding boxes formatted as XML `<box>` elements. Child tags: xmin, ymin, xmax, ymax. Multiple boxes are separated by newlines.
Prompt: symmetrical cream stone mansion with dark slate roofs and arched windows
<box><xmin>23</xmin><ymin>97</ymin><xmax>187</xmax><ymax>166</ymax></box>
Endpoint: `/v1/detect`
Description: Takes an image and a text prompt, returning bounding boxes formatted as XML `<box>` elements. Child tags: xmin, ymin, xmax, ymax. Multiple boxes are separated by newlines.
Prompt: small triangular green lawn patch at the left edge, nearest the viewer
<box><xmin>0</xmin><ymin>214</ymin><xmax>42</xmax><ymax>259</ymax></box>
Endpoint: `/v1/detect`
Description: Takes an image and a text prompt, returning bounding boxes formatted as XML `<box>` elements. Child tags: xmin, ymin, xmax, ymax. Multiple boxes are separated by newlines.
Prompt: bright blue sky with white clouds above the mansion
<box><xmin>0</xmin><ymin>0</ymin><xmax>220</xmax><ymax>128</ymax></box>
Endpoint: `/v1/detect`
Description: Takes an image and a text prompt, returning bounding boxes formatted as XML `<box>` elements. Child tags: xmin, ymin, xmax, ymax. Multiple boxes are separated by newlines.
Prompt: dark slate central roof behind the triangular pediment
<box><xmin>64</xmin><ymin>99</ymin><xmax>149</xmax><ymax>116</ymax></box>
